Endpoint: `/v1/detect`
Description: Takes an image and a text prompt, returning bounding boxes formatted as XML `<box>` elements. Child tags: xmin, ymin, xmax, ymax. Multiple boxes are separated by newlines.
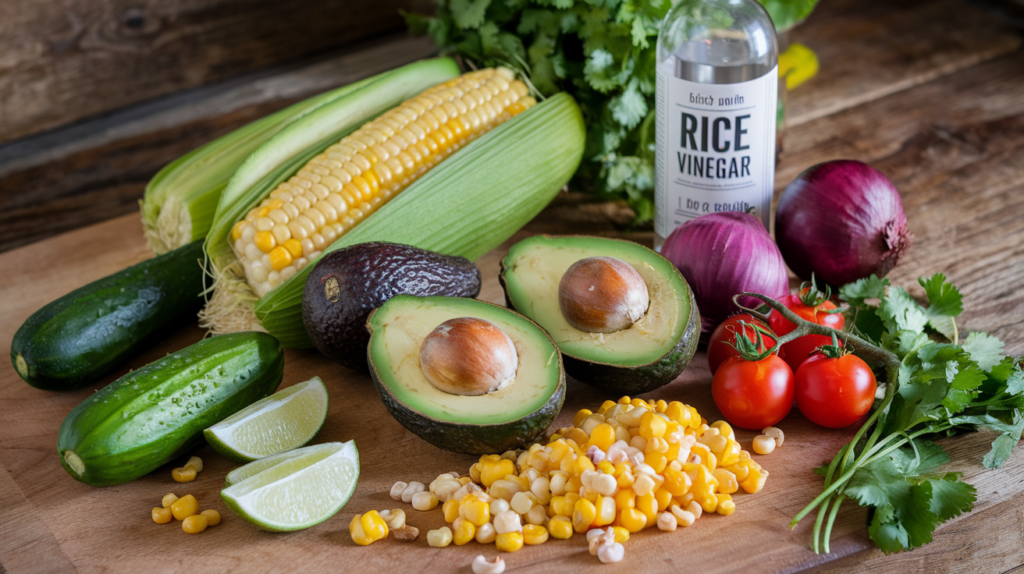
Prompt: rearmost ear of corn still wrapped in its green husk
<box><xmin>139</xmin><ymin>73</ymin><xmax>380</xmax><ymax>255</ymax></box>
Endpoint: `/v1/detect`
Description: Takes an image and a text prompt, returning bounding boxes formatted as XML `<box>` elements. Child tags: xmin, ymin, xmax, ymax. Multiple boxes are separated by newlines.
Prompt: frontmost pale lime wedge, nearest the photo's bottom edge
<box><xmin>220</xmin><ymin>441</ymin><xmax>359</xmax><ymax>531</ymax></box>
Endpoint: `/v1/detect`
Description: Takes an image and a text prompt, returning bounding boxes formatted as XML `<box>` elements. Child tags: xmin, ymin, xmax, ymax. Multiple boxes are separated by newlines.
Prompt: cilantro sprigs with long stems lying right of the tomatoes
<box><xmin>741</xmin><ymin>273</ymin><xmax>1024</xmax><ymax>554</ymax></box>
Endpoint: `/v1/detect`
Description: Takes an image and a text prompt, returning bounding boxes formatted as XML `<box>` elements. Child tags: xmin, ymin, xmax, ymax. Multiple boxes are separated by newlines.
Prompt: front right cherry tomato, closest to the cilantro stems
<box><xmin>796</xmin><ymin>354</ymin><xmax>878</xmax><ymax>429</ymax></box>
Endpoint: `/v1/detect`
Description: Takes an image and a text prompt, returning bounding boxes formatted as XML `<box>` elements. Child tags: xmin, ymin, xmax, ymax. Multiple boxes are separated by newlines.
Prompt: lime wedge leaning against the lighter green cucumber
<box><xmin>203</xmin><ymin>377</ymin><xmax>328</xmax><ymax>462</ymax></box>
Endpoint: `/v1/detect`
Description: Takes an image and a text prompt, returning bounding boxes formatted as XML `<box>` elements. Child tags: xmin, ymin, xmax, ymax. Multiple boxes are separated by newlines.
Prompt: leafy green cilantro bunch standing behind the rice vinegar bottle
<box><xmin>406</xmin><ymin>0</ymin><xmax>817</xmax><ymax>222</ymax></box>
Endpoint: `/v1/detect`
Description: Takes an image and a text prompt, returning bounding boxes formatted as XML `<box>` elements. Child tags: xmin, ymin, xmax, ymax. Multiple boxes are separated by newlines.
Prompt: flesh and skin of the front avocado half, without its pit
<box><xmin>367</xmin><ymin>295</ymin><xmax>565</xmax><ymax>454</ymax></box>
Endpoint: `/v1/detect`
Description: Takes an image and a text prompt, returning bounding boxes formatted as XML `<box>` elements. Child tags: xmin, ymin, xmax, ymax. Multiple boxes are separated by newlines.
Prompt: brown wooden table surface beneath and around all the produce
<box><xmin>0</xmin><ymin>0</ymin><xmax>1024</xmax><ymax>572</ymax></box>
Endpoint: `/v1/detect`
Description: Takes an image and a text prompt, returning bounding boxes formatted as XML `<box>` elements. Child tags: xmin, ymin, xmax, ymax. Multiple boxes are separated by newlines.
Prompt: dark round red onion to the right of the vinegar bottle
<box><xmin>775</xmin><ymin>160</ymin><xmax>913</xmax><ymax>286</ymax></box>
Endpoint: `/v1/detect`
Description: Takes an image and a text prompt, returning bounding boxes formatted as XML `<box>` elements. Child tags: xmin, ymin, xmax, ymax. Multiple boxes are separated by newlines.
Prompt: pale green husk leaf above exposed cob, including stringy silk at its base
<box><xmin>200</xmin><ymin>57</ymin><xmax>459</xmax><ymax>334</ymax></box>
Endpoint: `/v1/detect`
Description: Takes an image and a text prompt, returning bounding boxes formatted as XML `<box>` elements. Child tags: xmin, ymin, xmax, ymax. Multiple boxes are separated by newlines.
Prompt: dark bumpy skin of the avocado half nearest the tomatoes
<box><xmin>498</xmin><ymin>261</ymin><xmax>700</xmax><ymax>396</ymax></box>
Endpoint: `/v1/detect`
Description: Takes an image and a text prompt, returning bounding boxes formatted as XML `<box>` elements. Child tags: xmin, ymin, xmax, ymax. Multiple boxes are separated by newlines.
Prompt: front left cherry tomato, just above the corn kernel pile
<box><xmin>711</xmin><ymin>355</ymin><xmax>794</xmax><ymax>431</ymax></box>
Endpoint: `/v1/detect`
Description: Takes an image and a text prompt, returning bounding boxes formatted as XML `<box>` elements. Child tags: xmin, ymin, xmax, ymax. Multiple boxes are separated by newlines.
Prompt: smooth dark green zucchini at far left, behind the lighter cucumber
<box><xmin>10</xmin><ymin>237</ymin><xmax>204</xmax><ymax>391</ymax></box>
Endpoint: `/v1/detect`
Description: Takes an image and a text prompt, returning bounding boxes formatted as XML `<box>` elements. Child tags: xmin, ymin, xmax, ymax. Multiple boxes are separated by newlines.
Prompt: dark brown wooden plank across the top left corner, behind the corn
<box><xmin>0</xmin><ymin>0</ymin><xmax>431</xmax><ymax>142</ymax></box>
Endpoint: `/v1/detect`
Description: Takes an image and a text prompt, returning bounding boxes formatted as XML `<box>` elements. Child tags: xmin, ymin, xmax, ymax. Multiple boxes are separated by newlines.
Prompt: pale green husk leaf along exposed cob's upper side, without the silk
<box><xmin>206</xmin><ymin>58</ymin><xmax>459</xmax><ymax>271</ymax></box>
